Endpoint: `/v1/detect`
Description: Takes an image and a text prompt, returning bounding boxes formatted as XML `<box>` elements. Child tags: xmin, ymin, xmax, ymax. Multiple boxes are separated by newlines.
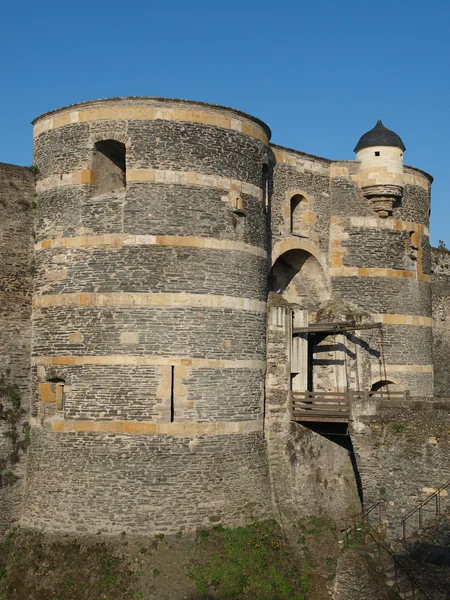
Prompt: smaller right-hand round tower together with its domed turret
<box><xmin>348</xmin><ymin>121</ymin><xmax>433</xmax><ymax>396</ymax></box>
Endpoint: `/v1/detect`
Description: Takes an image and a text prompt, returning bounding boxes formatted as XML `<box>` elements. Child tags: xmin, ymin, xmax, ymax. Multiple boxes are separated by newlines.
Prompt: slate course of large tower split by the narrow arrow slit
<box><xmin>31</xmin><ymin>365</ymin><xmax>262</xmax><ymax>423</ymax></box>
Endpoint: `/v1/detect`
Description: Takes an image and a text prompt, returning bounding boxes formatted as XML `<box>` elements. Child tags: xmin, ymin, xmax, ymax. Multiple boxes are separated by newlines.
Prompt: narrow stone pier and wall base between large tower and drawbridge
<box><xmin>265</xmin><ymin>296</ymin><xmax>360</xmax><ymax>524</ymax></box>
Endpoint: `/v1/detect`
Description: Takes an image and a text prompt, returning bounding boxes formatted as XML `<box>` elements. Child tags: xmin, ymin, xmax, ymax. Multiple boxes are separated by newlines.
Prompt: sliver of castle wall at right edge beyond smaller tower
<box><xmin>431</xmin><ymin>248</ymin><xmax>450</xmax><ymax>398</ymax></box>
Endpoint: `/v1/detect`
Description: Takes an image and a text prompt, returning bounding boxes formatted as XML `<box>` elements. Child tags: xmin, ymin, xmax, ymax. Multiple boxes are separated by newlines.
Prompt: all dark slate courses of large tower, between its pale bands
<box><xmin>28</xmin><ymin>98</ymin><xmax>270</xmax><ymax>533</ymax></box>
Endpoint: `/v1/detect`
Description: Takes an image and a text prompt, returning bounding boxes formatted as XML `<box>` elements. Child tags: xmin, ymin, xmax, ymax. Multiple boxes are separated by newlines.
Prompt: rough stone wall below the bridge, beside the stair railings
<box><xmin>351</xmin><ymin>399</ymin><xmax>450</xmax><ymax>536</ymax></box>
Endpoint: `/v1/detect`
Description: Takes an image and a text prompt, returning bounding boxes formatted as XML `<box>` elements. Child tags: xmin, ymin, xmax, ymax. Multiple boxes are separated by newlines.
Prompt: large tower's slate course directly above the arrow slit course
<box><xmin>33</xmin><ymin>306</ymin><xmax>266</xmax><ymax>360</ymax></box>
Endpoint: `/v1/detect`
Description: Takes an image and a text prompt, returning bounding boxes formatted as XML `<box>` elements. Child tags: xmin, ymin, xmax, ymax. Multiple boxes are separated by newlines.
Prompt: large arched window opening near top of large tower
<box><xmin>92</xmin><ymin>140</ymin><xmax>126</xmax><ymax>196</ymax></box>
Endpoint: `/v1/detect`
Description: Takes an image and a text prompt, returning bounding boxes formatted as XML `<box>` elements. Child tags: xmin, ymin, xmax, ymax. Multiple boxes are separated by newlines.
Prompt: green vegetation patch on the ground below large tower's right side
<box><xmin>189</xmin><ymin>521</ymin><xmax>308</xmax><ymax>600</ymax></box>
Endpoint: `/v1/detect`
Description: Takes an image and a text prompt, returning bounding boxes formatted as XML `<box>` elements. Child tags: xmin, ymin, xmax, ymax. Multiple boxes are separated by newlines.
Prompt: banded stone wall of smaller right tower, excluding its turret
<box><xmin>330</xmin><ymin>162</ymin><xmax>433</xmax><ymax>396</ymax></box>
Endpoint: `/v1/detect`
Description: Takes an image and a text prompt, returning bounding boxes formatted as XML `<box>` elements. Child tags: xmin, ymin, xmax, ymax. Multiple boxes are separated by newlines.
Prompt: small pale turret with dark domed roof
<box><xmin>354</xmin><ymin>120</ymin><xmax>406</xmax><ymax>218</ymax></box>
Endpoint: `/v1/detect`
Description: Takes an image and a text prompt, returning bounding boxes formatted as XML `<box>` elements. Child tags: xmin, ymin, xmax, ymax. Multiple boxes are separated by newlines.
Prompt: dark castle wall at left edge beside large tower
<box><xmin>0</xmin><ymin>163</ymin><xmax>35</xmax><ymax>533</ymax></box>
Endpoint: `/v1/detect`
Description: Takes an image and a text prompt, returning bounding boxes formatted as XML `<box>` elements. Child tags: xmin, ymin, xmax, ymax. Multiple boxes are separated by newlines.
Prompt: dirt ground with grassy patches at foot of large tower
<box><xmin>0</xmin><ymin>518</ymin><xmax>339</xmax><ymax>600</ymax></box>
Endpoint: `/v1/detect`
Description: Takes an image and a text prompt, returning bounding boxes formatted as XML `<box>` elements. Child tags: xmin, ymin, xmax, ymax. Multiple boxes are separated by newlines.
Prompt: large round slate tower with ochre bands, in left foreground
<box><xmin>23</xmin><ymin>98</ymin><xmax>270</xmax><ymax>533</ymax></box>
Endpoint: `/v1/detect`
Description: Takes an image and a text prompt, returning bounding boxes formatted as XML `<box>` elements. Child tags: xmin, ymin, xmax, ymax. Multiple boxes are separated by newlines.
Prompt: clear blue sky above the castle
<box><xmin>0</xmin><ymin>0</ymin><xmax>450</xmax><ymax>247</ymax></box>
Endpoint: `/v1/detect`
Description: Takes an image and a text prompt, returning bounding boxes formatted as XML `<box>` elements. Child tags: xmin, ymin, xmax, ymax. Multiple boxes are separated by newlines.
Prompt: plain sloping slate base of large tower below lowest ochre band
<box><xmin>23</xmin><ymin>429</ymin><xmax>270</xmax><ymax>534</ymax></box>
